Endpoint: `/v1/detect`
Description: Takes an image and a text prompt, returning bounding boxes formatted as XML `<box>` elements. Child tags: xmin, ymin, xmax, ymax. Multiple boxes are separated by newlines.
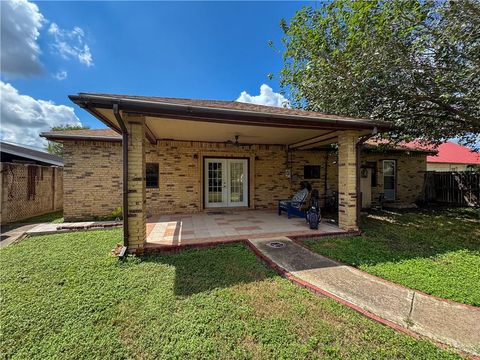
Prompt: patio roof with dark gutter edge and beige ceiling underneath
<box><xmin>65</xmin><ymin>93</ymin><xmax>391</xmax><ymax>148</ymax></box>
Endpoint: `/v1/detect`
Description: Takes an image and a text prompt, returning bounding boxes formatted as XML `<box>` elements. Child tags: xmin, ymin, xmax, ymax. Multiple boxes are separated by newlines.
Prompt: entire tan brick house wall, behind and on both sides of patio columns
<box><xmin>64</xmin><ymin>141</ymin><xmax>426</xmax><ymax>220</ymax></box>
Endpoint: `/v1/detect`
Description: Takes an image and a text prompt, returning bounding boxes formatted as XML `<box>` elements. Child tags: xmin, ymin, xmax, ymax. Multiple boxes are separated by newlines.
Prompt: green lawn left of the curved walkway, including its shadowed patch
<box><xmin>0</xmin><ymin>230</ymin><xmax>459</xmax><ymax>359</ymax></box>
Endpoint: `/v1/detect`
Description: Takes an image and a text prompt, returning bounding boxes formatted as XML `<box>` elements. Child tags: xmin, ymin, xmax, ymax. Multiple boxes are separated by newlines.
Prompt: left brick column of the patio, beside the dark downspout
<box><xmin>124</xmin><ymin>114</ymin><xmax>147</xmax><ymax>252</ymax></box>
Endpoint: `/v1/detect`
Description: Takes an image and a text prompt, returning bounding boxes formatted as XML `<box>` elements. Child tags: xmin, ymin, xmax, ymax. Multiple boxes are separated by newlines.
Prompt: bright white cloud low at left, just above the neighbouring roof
<box><xmin>0</xmin><ymin>81</ymin><xmax>80</xmax><ymax>147</ymax></box>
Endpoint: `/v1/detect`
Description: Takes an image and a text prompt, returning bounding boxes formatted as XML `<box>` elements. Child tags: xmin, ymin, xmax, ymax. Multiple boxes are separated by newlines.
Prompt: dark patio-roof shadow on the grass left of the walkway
<box><xmin>137</xmin><ymin>244</ymin><xmax>276</xmax><ymax>297</ymax></box>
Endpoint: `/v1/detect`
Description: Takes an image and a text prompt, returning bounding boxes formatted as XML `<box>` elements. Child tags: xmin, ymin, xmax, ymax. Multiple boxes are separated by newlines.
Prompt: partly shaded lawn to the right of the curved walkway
<box><xmin>305</xmin><ymin>208</ymin><xmax>480</xmax><ymax>306</ymax></box>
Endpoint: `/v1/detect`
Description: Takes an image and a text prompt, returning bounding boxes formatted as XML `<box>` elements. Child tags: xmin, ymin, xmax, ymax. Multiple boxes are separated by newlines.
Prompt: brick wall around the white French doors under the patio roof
<box><xmin>146</xmin><ymin>141</ymin><xmax>291</xmax><ymax>214</ymax></box>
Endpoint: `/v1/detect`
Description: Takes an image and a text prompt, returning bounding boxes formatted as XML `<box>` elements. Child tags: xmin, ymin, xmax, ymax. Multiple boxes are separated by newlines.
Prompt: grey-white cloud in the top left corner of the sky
<box><xmin>0</xmin><ymin>0</ymin><xmax>45</xmax><ymax>76</ymax></box>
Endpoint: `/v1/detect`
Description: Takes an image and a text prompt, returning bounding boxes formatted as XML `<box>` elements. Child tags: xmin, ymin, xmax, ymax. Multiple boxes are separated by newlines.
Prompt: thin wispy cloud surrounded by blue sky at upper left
<box><xmin>48</xmin><ymin>23</ymin><xmax>93</xmax><ymax>67</ymax></box>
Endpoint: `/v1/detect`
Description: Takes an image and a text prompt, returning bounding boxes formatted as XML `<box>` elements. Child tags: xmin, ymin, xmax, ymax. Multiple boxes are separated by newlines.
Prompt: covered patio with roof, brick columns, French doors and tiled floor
<box><xmin>70</xmin><ymin>93</ymin><xmax>389</xmax><ymax>252</ymax></box>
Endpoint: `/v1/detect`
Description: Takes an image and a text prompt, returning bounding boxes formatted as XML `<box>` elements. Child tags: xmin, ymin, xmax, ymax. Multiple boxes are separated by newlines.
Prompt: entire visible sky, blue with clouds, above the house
<box><xmin>0</xmin><ymin>0</ymin><xmax>480</xmax><ymax>147</ymax></box>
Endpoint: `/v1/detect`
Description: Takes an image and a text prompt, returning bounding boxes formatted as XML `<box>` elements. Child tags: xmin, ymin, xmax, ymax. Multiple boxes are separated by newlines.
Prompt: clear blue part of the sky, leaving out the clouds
<box><xmin>2</xmin><ymin>0</ymin><xmax>309</xmax><ymax>144</ymax></box>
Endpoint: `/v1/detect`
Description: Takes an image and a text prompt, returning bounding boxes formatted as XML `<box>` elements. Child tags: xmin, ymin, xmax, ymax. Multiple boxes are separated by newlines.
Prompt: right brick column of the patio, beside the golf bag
<box><xmin>338</xmin><ymin>131</ymin><xmax>358</xmax><ymax>230</ymax></box>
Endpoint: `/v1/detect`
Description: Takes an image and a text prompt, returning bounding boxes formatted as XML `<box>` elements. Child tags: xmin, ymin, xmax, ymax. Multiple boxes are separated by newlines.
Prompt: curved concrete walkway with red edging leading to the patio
<box><xmin>249</xmin><ymin>237</ymin><xmax>480</xmax><ymax>355</ymax></box>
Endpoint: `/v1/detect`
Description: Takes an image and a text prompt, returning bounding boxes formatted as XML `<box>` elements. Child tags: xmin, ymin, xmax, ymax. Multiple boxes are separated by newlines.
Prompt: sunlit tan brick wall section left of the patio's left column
<box><xmin>63</xmin><ymin>141</ymin><xmax>122</xmax><ymax>221</ymax></box>
